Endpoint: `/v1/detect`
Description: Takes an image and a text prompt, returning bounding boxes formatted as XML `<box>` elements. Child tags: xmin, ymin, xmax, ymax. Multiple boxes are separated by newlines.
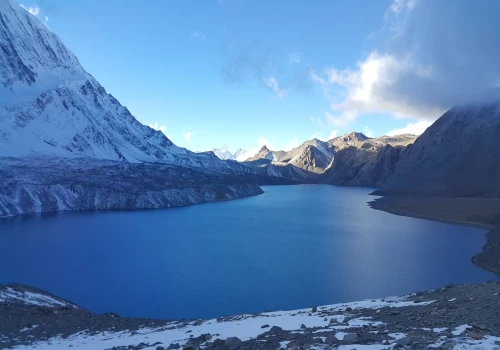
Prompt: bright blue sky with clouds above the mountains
<box><xmin>18</xmin><ymin>0</ymin><xmax>500</xmax><ymax>152</ymax></box>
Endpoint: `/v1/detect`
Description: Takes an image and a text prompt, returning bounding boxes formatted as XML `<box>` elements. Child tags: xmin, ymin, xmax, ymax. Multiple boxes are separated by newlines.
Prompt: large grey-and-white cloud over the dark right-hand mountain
<box><xmin>311</xmin><ymin>0</ymin><xmax>500</xmax><ymax>126</ymax></box>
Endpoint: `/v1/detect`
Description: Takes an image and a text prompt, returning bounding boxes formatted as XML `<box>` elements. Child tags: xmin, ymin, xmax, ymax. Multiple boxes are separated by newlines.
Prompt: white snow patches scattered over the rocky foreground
<box><xmin>0</xmin><ymin>285</ymin><xmax>500</xmax><ymax>350</ymax></box>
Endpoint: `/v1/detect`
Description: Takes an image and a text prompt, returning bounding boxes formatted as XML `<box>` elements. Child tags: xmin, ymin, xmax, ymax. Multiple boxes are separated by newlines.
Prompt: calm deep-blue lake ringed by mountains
<box><xmin>0</xmin><ymin>185</ymin><xmax>499</xmax><ymax>318</ymax></box>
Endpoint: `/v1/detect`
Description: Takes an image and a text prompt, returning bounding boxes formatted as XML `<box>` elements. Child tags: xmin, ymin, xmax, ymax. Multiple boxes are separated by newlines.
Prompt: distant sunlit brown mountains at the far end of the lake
<box><xmin>243</xmin><ymin>132</ymin><xmax>416</xmax><ymax>186</ymax></box>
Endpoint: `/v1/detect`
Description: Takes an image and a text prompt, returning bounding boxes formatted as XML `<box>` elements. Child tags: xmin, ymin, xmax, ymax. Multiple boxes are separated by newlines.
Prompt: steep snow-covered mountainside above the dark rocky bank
<box><xmin>0</xmin><ymin>0</ymin><xmax>244</xmax><ymax>171</ymax></box>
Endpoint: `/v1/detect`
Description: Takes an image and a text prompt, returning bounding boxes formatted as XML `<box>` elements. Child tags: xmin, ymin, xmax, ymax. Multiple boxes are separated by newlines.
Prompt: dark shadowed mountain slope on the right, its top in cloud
<box><xmin>382</xmin><ymin>99</ymin><xmax>500</xmax><ymax>197</ymax></box>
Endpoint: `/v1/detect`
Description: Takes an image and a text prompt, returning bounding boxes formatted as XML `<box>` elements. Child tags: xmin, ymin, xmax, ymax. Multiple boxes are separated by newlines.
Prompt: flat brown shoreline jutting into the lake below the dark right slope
<box><xmin>369</xmin><ymin>196</ymin><xmax>500</xmax><ymax>275</ymax></box>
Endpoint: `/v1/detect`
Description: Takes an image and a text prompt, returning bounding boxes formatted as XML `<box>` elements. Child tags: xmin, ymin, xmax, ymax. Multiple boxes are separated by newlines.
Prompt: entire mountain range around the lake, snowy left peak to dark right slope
<box><xmin>0</xmin><ymin>0</ymin><xmax>500</xmax><ymax>216</ymax></box>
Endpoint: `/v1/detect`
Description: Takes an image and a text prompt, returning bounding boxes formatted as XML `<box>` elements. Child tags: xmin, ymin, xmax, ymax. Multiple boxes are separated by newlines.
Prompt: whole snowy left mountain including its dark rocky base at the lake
<box><xmin>0</xmin><ymin>0</ymin><xmax>272</xmax><ymax>217</ymax></box>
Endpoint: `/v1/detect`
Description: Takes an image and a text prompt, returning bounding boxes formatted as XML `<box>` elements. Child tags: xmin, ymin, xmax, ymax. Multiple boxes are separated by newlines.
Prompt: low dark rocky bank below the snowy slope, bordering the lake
<box><xmin>0</xmin><ymin>158</ymin><xmax>264</xmax><ymax>217</ymax></box>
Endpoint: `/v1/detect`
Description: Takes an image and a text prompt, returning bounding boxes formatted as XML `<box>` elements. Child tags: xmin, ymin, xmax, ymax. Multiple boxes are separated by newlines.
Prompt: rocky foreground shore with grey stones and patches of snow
<box><xmin>0</xmin><ymin>282</ymin><xmax>500</xmax><ymax>350</ymax></box>
